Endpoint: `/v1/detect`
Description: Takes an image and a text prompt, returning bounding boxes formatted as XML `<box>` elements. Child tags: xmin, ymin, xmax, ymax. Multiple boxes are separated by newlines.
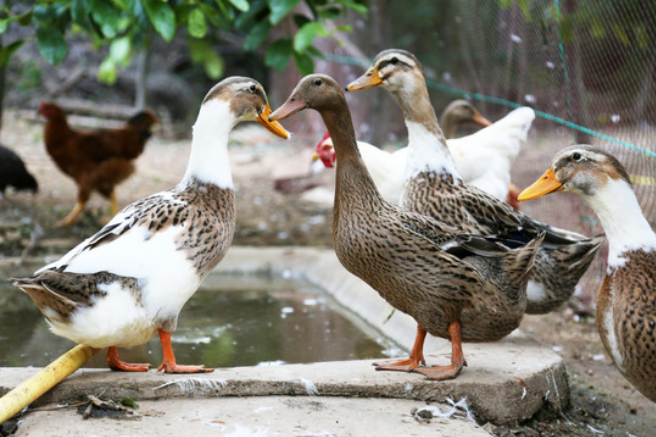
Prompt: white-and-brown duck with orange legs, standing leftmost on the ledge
<box><xmin>13</xmin><ymin>76</ymin><xmax>289</xmax><ymax>373</ymax></box>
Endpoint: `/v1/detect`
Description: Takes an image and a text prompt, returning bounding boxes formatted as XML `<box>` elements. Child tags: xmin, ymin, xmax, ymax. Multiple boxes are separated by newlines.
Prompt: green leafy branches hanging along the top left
<box><xmin>0</xmin><ymin>0</ymin><xmax>367</xmax><ymax>83</ymax></box>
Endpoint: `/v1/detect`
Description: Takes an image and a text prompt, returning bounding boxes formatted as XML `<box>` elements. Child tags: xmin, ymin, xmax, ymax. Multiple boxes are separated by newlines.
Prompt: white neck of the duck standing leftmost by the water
<box><xmin>181</xmin><ymin>100</ymin><xmax>237</xmax><ymax>189</ymax></box>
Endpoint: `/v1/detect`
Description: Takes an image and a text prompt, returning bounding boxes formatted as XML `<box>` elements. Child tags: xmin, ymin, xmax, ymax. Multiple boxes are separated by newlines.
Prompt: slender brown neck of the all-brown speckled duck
<box><xmin>321</xmin><ymin>99</ymin><xmax>383</xmax><ymax>215</ymax></box>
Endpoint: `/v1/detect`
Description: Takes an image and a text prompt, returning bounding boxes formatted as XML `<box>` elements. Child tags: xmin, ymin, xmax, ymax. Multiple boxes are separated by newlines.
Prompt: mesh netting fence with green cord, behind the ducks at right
<box><xmin>326</xmin><ymin>0</ymin><xmax>656</xmax><ymax>304</ymax></box>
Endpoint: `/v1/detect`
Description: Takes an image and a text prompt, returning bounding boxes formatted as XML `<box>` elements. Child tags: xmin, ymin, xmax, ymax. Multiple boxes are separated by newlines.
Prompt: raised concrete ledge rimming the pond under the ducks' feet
<box><xmin>0</xmin><ymin>247</ymin><xmax>569</xmax><ymax>428</ymax></box>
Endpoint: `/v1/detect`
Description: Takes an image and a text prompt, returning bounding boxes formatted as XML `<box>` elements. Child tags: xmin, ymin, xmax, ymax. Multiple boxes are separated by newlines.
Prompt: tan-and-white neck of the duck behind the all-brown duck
<box><xmin>392</xmin><ymin>80</ymin><xmax>460</xmax><ymax>181</ymax></box>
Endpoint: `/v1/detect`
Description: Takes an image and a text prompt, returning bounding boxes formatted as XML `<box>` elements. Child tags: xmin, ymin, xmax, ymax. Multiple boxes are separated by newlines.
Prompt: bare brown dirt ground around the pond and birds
<box><xmin>0</xmin><ymin>112</ymin><xmax>656</xmax><ymax>437</ymax></box>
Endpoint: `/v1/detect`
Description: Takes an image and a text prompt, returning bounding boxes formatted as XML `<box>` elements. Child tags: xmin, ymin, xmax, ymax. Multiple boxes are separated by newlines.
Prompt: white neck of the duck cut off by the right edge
<box><xmin>587</xmin><ymin>179</ymin><xmax>656</xmax><ymax>268</ymax></box>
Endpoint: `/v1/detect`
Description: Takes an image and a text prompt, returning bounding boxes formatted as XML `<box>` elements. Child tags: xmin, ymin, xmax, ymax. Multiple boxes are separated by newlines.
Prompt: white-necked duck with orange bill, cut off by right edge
<box><xmin>519</xmin><ymin>144</ymin><xmax>656</xmax><ymax>402</ymax></box>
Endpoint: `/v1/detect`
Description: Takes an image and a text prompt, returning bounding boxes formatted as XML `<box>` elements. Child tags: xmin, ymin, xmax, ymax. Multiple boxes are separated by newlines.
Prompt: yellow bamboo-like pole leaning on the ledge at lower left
<box><xmin>0</xmin><ymin>345</ymin><xmax>98</xmax><ymax>424</ymax></box>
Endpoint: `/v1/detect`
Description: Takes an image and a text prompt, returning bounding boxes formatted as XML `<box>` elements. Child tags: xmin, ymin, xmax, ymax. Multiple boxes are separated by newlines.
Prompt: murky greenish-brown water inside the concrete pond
<box><xmin>0</xmin><ymin>262</ymin><xmax>395</xmax><ymax>367</ymax></box>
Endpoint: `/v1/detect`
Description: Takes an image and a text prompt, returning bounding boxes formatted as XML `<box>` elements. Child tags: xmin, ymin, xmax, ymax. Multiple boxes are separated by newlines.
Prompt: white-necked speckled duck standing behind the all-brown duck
<box><xmin>346</xmin><ymin>49</ymin><xmax>603</xmax><ymax>314</ymax></box>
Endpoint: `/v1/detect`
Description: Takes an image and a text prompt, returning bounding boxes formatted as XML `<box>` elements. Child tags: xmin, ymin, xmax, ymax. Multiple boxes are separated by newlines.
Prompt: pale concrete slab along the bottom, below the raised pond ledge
<box><xmin>16</xmin><ymin>396</ymin><xmax>489</xmax><ymax>437</ymax></box>
